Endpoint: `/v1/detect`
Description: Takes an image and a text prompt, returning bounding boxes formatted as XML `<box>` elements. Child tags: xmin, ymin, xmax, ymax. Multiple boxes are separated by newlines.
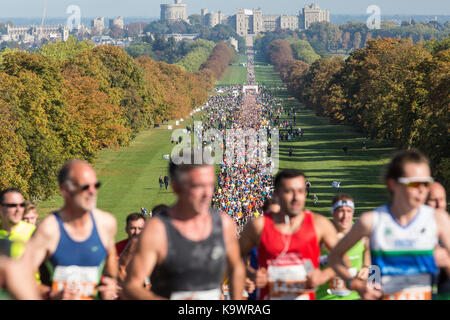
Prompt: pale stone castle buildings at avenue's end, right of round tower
<box><xmin>201</xmin><ymin>4</ymin><xmax>330</xmax><ymax>36</ymax></box>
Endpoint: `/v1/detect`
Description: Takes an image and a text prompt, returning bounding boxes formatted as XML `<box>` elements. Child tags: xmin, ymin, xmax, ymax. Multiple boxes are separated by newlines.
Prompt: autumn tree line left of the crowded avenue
<box><xmin>0</xmin><ymin>39</ymin><xmax>234</xmax><ymax>199</ymax></box>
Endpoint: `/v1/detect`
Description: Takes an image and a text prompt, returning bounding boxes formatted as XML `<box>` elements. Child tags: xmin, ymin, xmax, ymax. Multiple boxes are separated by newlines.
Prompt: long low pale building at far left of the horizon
<box><xmin>1</xmin><ymin>25</ymin><xmax>70</xmax><ymax>43</ymax></box>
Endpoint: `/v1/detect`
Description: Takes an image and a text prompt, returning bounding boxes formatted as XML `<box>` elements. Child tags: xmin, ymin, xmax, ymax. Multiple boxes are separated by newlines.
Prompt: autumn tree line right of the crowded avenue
<box><xmin>269</xmin><ymin>37</ymin><xmax>450</xmax><ymax>190</ymax></box>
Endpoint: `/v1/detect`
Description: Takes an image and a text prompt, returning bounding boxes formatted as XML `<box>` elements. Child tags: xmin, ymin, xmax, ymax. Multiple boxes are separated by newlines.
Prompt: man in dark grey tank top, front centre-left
<box><xmin>124</xmin><ymin>152</ymin><xmax>245</xmax><ymax>300</ymax></box>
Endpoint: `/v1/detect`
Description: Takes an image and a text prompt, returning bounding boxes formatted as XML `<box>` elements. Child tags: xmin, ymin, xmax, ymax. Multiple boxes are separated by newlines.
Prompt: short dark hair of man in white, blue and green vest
<box><xmin>384</xmin><ymin>149</ymin><xmax>430</xmax><ymax>182</ymax></box>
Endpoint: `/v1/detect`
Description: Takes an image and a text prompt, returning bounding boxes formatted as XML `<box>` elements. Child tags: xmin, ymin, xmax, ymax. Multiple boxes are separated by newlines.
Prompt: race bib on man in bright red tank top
<box><xmin>267</xmin><ymin>253</ymin><xmax>314</xmax><ymax>300</ymax></box>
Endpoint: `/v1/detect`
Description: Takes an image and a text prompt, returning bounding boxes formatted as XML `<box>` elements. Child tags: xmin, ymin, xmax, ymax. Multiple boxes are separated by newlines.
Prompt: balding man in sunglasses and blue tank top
<box><xmin>25</xmin><ymin>160</ymin><xmax>118</xmax><ymax>300</ymax></box>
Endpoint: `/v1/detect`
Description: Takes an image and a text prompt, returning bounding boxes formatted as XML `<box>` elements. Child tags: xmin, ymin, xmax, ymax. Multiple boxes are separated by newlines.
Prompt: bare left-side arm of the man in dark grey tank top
<box><xmin>123</xmin><ymin>218</ymin><xmax>167</xmax><ymax>300</ymax></box>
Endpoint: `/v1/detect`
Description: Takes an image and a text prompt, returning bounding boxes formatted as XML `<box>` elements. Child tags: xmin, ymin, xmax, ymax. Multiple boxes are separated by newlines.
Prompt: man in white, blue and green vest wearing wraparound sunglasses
<box><xmin>329</xmin><ymin>149</ymin><xmax>450</xmax><ymax>300</ymax></box>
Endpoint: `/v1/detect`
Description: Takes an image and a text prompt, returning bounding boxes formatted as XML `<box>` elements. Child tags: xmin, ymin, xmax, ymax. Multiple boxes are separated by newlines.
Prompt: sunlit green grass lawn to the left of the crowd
<box><xmin>38</xmin><ymin>114</ymin><xmax>199</xmax><ymax>240</ymax></box>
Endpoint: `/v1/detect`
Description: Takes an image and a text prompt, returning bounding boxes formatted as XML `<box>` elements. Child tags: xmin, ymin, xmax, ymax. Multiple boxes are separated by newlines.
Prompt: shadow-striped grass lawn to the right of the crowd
<box><xmin>255</xmin><ymin>57</ymin><xmax>395</xmax><ymax>216</ymax></box>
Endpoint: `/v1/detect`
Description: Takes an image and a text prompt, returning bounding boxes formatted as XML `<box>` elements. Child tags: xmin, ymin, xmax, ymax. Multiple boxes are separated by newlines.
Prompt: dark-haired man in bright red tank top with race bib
<box><xmin>239</xmin><ymin>169</ymin><xmax>340</xmax><ymax>300</ymax></box>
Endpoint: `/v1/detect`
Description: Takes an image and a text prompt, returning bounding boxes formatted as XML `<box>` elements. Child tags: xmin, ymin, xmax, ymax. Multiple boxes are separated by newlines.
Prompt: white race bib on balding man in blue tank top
<box><xmin>52</xmin><ymin>266</ymin><xmax>100</xmax><ymax>300</ymax></box>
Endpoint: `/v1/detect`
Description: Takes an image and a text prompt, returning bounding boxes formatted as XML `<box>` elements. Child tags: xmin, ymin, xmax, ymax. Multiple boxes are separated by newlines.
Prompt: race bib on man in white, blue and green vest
<box><xmin>381</xmin><ymin>274</ymin><xmax>432</xmax><ymax>300</ymax></box>
